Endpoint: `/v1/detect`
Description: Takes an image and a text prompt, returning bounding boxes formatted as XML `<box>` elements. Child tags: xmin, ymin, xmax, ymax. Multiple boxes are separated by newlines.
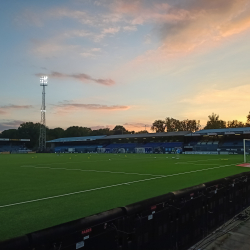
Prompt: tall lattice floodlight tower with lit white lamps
<box><xmin>39</xmin><ymin>76</ymin><xmax>48</xmax><ymax>152</ymax></box>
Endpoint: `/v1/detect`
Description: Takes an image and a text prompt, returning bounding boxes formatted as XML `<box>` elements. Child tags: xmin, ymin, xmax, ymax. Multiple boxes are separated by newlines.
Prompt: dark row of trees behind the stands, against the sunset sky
<box><xmin>0</xmin><ymin>112</ymin><xmax>250</xmax><ymax>148</ymax></box>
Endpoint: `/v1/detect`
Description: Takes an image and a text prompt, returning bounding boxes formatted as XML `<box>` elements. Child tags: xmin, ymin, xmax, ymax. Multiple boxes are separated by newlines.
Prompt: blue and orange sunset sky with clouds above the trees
<box><xmin>0</xmin><ymin>0</ymin><xmax>250</xmax><ymax>132</ymax></box>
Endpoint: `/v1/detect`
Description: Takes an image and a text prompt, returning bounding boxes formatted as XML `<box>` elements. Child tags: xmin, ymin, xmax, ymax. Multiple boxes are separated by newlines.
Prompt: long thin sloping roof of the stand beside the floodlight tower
<box><xmin>47</xmin><ymin>131</ymin><xmax>190</xmax><ymax>142</ymax></box>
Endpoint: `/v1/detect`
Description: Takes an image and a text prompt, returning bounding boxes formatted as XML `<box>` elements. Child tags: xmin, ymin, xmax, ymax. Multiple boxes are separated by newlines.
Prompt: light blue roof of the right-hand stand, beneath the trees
<box><xmin>186</xmin><ymin>127</ymin><xmax>250</xmax><ymax>136</ymax></box>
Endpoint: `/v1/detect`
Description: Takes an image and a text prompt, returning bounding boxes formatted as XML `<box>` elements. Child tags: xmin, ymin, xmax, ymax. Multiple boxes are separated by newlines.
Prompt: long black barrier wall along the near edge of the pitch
<box><xmin>0</xmin><ymin>172</ymin><xmax>250</xmax><ymax>250</ymax></box>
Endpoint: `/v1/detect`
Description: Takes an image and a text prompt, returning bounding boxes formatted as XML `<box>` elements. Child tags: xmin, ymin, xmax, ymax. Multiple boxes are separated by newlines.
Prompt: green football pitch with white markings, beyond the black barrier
<box><xmin>0</xmin><ymin>154</ymin><xmax>249</xmax><ymax>240</ymax></box>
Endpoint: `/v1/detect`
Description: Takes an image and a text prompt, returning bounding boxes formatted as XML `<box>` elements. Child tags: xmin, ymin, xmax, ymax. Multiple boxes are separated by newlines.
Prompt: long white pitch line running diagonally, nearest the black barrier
<box><xmin>0</xmin><ymin>163</ymin><xmax>238</xmax><ymax>208</ymax></box>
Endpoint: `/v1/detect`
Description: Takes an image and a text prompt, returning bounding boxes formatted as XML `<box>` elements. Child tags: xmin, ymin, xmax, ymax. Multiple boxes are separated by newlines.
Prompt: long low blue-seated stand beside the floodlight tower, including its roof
<box><xmin>47</xmin><ymin>131</ymin><xmax>189</xmax><ymax>153</ymax></box>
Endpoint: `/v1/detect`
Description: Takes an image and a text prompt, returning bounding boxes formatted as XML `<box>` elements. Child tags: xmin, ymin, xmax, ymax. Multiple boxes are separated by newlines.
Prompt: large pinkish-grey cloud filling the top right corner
<box><xmin>113</xmin><ymin>0</ymin><xmax>250</xmax><ymax>55</ymax></box>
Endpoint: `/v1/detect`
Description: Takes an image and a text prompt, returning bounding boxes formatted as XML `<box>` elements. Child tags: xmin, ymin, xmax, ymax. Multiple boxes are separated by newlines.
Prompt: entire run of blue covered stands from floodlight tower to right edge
<box><xmin>48</xmin><ymin>127</ymin><xmax>250</xmax><ymax>154</ymax></box>
